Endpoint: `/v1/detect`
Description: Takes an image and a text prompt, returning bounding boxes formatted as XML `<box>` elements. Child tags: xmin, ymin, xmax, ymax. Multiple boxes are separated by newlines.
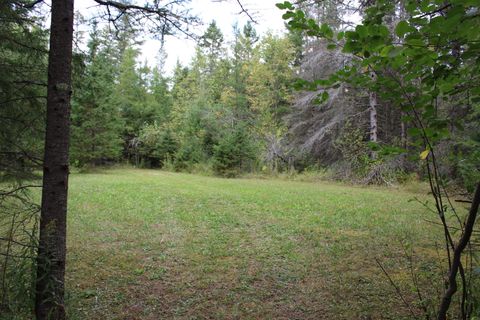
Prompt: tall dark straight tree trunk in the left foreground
<box><xmin>35</xmin><ymin>0</ymin><xmax>73</xmax><ymax>320</ymax></box>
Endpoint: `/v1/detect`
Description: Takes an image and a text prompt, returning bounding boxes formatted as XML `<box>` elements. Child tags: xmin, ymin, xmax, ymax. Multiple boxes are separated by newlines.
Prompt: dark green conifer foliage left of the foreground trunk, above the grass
<box><xmin>0</xmin><ymin>1</ymin><xmax>47</xmax><ymax>182</ymax></box>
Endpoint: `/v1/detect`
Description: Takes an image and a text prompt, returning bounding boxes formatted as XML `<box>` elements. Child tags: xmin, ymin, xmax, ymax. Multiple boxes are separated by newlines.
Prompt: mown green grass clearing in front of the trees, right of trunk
<box><xmin>67</xmin><ymin>169</ymin><xmax>440</xmax><ymax>320</ymax></box>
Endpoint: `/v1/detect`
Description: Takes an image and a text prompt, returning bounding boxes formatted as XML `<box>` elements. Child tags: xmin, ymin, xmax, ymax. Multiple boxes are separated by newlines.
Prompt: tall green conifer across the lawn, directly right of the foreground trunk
<box><xmin>71</xmin><ymin>26</ymin><xmax>123</xmax><ymax>165</ymax></box>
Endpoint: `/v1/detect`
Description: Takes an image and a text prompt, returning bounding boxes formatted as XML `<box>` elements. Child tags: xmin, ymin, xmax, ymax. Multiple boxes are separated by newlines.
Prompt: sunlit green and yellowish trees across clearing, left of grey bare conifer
<box><xmin>70</xmin><ymin>20</ymin><xmax>295</xmax><ymax>176</ymax></box>
